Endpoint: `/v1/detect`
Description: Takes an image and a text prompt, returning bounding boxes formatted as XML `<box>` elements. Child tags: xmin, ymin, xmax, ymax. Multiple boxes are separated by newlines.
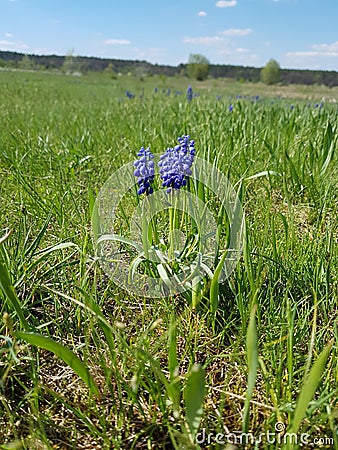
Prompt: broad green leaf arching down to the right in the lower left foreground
<box><xmin>14</xmin><ymin>331</ymin><xmax>99</xmax><ymax>396</ymax></box>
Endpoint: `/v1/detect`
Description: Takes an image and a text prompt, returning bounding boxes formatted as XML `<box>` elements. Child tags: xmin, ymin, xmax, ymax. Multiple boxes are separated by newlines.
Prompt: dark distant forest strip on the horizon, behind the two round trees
<box><xmin>0</xmin><ymin>51</ymin><xmax>338</xmax><ymax>87</ymax></box>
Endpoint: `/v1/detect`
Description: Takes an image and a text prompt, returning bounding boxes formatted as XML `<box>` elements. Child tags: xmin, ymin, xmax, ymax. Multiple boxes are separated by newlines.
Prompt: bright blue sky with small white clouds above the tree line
<box><xmin>0</xmin><ymin>0</ymin><xmax>338</xmax><ymax>71</ymax></box>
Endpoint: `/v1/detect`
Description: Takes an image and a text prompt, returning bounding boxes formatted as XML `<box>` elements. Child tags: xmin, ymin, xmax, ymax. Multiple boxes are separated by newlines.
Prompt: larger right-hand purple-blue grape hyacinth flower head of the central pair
<box><xmin>158</xmin><ymin>135</ymin><xmax>195</xmax><ymax>193</ymax></box>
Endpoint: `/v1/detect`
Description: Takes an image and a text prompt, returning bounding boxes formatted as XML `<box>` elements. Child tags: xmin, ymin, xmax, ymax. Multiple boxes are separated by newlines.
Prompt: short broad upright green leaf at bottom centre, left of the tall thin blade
<box><xmin>184</xmin><ymin>364</ymin><xmax>205</xmax><ymax>438</ymax></box>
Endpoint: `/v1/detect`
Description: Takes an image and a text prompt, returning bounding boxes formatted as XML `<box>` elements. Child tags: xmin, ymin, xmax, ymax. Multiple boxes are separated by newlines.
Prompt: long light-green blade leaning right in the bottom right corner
<box><xmin>290</xmin><ymin>340</ymin><xmax>333</xmax><ymax>433</ymax></box>
